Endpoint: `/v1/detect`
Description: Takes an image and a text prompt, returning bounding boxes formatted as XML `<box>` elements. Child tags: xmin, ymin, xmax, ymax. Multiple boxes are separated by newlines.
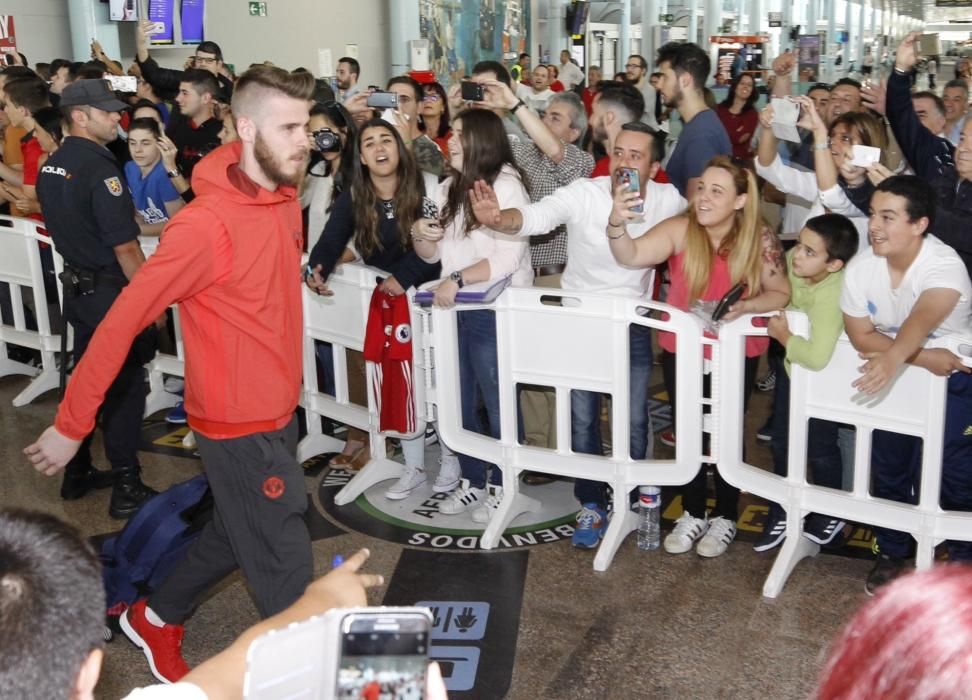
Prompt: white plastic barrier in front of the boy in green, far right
<box><xmin>712</xmin><ymin>312</ymin><xmax>972</xmax><ymax>598</ymax></box>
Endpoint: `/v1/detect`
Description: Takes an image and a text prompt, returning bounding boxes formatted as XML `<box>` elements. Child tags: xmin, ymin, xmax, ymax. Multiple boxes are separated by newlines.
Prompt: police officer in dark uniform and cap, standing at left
<box><xmin>37</xmin><ymin>80</ymin><xmax>157</xmax><ymax>518</ymax></box>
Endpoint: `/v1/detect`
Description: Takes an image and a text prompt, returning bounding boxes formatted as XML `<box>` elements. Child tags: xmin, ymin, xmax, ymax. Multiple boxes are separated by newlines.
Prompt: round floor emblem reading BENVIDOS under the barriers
<box><xmin>318</xmin><ymin>469</ymin><xmax>578</xmax><ymax>550</ymax></box>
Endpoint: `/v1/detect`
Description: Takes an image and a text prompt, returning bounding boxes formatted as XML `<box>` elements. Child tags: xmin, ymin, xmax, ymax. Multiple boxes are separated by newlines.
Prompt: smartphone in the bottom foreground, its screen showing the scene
<box><xmin>334</xmin><ymin>608</ymin><xmax>432</xmax><ymax>700</ymax></box>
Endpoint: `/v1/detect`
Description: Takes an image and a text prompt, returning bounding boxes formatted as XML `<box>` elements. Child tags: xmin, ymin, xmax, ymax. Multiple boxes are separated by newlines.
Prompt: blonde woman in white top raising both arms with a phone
<box><xmin>756</xmin><ymin>96</ymin><xmax>888</xmax><ymax>248</ymax></box>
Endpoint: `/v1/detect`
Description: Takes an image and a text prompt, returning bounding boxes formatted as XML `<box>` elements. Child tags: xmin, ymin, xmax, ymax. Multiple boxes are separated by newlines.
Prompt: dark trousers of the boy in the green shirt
<box><xmin>770</xmin><ymin>370</ymin><xmax>843</xmax><ymax>522</ymax></box>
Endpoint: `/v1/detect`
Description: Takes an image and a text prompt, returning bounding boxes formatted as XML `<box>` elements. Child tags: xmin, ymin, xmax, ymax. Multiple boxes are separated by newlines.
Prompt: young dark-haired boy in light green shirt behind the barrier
<box><xmin>753</xmin><ymin>214</ymin><xmax>858</xmax><ymax>552</ymax></box>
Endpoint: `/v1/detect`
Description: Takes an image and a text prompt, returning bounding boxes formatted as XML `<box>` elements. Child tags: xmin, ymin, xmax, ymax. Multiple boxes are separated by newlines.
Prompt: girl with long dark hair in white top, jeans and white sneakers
<box><xmin>412</xmin><ymin>109</ymin><xmax>533</xmax><ymax>523</ymax></box>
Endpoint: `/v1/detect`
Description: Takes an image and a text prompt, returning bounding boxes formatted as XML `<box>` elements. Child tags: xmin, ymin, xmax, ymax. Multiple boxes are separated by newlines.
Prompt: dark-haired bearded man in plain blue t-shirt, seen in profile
<box><xmin>658</xmin><ymin>43</ymin><xmax>732</xmax><ymax>200</ymax></box>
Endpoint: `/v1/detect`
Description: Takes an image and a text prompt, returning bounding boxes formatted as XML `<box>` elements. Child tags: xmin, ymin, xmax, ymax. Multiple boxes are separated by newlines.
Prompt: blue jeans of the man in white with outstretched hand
<box><xmin>570</xmin><ymin>325</ymin><xmax>652</xmax><ymax>508</ymax></box>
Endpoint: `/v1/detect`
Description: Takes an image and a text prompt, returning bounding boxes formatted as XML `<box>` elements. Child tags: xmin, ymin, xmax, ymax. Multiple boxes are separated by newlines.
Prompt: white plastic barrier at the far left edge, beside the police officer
<box><xmin>0</xmin><ymin>216</ymin><xmax>71</xmax><ymax>406</ymax></box>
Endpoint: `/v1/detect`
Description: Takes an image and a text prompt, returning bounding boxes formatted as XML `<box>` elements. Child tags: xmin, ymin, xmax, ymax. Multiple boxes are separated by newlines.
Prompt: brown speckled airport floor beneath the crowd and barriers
<box><xmin>0</xmin><ymin>366</ymin><xmax>871</xmax><ymax>700</ymax></box>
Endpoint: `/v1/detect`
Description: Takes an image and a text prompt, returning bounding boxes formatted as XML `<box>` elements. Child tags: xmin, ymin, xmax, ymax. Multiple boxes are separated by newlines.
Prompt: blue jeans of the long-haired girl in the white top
<box><xmin>456</xmin><ymin>309</ymin><xmax>503</xmax><ymax>488</ymax></box>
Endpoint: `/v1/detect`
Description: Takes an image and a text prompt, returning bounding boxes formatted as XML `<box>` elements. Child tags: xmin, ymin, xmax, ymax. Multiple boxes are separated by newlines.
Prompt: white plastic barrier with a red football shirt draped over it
<box><xmin>297</xmin><ymin>263</ymin><xmax>431</xmax><ymax>505</ymax></box>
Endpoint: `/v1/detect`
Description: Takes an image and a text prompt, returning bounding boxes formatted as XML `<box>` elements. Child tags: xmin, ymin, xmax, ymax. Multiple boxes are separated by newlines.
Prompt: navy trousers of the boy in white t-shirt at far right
<box><xmin>871</xmin><ymin>373</ymin><xmax>972</xmax><ymax>561</ymax></box>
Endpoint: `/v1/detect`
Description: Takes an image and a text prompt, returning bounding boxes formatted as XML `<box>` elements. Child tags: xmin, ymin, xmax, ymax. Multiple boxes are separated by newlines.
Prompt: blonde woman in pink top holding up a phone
<box><xmin>607</xmin><ymin>156</ymin><xmax>790</xmax><ymax>557</ymax></box>
